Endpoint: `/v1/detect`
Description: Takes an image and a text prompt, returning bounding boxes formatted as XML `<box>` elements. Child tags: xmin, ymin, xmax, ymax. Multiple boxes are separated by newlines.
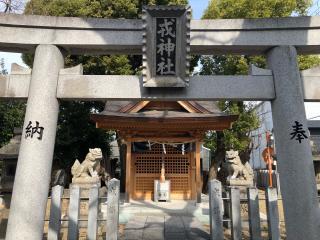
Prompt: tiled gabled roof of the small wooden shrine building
<box><xmin>91</xmin><ymin>101</ymin><xmax>238</xmax><ymax>131</ymax></box>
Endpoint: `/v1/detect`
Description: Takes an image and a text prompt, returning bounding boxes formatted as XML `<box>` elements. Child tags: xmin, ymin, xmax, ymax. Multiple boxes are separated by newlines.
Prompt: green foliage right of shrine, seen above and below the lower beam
<box><xmin>200</xmin><ymin>55</ymin><xmax>265</xmax><ymax>152</ymax></box>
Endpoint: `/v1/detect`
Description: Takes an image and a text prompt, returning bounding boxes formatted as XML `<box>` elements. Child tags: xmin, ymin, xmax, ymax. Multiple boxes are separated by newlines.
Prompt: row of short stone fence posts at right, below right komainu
<box><xmin>209</xmin><ymin>180</ymin><xmax>284</xmax><ymax>240</ymax></box>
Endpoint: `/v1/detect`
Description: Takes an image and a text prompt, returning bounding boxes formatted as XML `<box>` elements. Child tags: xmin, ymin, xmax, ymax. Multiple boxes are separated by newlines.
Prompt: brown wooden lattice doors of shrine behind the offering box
<box><xmin>131</xmin><ymin>144</ymin><xmax>191</xmax><ymax>200</ymax></box>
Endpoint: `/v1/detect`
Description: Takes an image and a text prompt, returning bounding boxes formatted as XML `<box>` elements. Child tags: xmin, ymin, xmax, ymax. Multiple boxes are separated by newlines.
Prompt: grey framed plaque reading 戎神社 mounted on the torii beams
<box><xmin>142</xmin><ymin>6</ymin><xmax>191</xmax><ymax>87</ymax></box>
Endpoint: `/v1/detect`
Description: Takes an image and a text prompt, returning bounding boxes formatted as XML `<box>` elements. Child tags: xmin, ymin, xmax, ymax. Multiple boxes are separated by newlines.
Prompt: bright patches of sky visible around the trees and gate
<box><xmin>0</xmin><ymin>0</ymin><xmax>320</xmax><ymax>120</ymax></box>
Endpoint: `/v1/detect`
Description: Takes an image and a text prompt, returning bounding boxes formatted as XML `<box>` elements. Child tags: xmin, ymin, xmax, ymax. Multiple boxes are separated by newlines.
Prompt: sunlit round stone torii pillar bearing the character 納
<box><xmin>6</xmin><ymin>45</ymin><xmax>64</xmax><ymax>240</ymax></box>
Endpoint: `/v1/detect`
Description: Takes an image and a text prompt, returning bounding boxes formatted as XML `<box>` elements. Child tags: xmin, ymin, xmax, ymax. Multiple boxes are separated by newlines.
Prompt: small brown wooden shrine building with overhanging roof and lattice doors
<box><xmin>92</xmin><ymin>101</ymin><xmax>237</xmax><ymax>201</ymax></box>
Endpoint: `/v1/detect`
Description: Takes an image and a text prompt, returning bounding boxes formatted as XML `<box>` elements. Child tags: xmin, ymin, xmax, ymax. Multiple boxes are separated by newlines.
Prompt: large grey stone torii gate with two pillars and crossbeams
<box><xmin>0</xmin><ymin>11</ymin><xmax>320</xmax><ymax>240</ymax></box>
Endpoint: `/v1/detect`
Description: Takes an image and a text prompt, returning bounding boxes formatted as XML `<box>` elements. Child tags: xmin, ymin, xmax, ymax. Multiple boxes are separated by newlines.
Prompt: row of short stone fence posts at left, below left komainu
<box><xmin>47</xmin><ymin>179</ymin><xmax>120</xmax><ymax>240</ymax></box>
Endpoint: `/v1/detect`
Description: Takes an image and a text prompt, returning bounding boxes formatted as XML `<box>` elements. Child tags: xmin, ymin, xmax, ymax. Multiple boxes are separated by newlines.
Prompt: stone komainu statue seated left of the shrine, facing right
<box><xmin>71</xmin><ymin>148</ymin><xmax>102</xmax><ymax>178</ymax></box>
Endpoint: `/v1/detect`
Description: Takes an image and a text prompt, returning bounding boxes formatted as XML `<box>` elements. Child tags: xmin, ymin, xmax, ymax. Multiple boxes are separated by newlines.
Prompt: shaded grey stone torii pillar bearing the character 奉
<box><xmin>268</xmin><ymin>46</ymin><xmax>320</xmax><ymax>240</ymax></box>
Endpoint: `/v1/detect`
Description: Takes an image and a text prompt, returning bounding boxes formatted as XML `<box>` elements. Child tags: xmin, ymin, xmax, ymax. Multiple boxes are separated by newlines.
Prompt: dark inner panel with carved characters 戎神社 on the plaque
<box><xmin>156</xmin><ymin>18</ymin><xmax>177</xmax><ymax>76</ymax></box>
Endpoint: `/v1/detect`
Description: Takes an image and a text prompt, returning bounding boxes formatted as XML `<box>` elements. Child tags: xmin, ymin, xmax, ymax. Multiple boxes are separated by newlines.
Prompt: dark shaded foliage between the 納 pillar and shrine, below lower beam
<box><xmin>55</xmin><ymin>101</ymin><xmax>111</xmax><ymax>170</ymax></box>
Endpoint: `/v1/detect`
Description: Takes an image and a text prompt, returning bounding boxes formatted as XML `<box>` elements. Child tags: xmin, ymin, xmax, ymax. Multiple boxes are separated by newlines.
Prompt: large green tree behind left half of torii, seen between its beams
<box><xmin>23</xmin><ymin>0</ymin><xmax>187</xmax><ymax>176</ymax></box>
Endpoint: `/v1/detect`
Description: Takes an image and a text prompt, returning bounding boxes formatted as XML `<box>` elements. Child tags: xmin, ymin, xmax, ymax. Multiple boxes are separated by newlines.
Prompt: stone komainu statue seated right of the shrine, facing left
<box><xmin>225</xmin><ymin>150</ymin><xmax>253</xmax><ymax>181</ymax></box>
